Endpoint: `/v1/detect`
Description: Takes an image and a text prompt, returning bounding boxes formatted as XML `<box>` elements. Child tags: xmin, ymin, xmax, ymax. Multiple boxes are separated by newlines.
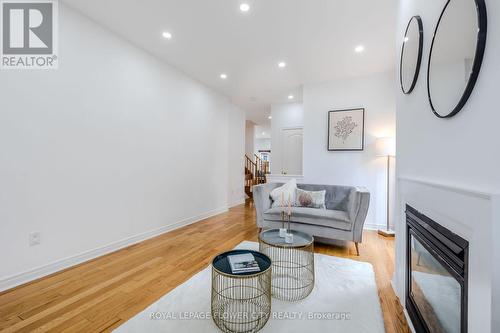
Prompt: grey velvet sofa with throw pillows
<box><xmin>252</xmin><ymin>183</ymin><xmax>370</xmax><ymax>255</ymax></box>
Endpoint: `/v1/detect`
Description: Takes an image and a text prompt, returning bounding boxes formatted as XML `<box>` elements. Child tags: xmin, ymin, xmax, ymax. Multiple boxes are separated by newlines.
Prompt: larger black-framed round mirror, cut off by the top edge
<box><xmin>427</xmin><ymin>0</ymin><xmax>487</xmax><ymax>118</ymax></box>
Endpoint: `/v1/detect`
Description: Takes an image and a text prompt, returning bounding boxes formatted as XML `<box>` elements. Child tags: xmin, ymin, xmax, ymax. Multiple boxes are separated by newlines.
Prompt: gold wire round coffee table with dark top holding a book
<box><xmin>211</xmin><ymin>250</ymin><xmax>271</xmax><ymax>333</ymax></box>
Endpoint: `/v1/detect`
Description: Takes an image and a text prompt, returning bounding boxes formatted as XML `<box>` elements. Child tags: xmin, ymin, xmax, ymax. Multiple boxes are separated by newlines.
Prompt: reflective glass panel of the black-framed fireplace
<box><xmin>410</xmin><ymin>235</ymin><xmax>461</xmax><ymax>333</ymax></box>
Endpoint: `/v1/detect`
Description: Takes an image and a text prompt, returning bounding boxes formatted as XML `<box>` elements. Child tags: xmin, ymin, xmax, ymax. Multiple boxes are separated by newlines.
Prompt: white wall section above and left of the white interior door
<box><xmin>271</xmin><ymin>103</ymin><xmax>304</xmax><ymax>175</ymax></box>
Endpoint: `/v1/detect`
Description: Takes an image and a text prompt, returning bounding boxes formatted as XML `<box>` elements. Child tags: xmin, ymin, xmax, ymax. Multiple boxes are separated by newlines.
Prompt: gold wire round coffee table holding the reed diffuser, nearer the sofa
<box><xmin>259</xmin><ymin>229</ymin><xmax>314</xmax><ymax>302</ymax></box>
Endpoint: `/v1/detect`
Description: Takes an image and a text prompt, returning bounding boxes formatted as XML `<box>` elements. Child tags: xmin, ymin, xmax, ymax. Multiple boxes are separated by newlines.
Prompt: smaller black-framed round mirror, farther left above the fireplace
<box><xmin>399</xmin><ymin>16</ymin><xmax>424</xmax><ymax>94</ymax></box>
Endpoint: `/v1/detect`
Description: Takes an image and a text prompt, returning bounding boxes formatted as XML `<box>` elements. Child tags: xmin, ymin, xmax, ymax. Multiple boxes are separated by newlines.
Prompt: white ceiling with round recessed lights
<box><xmin>64</xmin><ymin>0</ymin><xmax>397</xmax><ymax>125</ymax></box>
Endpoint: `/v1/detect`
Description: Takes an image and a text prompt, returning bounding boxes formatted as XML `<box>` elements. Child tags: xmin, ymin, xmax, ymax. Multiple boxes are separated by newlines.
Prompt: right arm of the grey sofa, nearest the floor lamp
<box><xmin>347</xmin><ymin>187</ymin><xmax>370</xmax><ymax>243</ymax></box>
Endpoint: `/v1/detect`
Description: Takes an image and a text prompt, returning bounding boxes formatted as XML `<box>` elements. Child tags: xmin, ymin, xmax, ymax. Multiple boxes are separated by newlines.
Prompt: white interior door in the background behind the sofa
<box><xmin>281</xmin><ymin>128</ymin><xmax>303</xmax><ymax>175</ymax></box>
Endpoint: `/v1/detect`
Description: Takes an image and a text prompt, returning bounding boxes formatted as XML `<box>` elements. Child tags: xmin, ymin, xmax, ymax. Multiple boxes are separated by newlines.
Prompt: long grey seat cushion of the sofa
<box><xmin>264</xmin><ymin>207</ymin><xmax>352</xmax><ymax>231</ymax></box>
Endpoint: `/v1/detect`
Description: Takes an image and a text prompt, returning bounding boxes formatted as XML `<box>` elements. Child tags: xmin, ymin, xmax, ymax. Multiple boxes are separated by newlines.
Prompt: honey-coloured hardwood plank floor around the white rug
<box><xmin>0</xmin><ymin>204</ymin><xmax>410</xmax><ymax>333</ymax></box>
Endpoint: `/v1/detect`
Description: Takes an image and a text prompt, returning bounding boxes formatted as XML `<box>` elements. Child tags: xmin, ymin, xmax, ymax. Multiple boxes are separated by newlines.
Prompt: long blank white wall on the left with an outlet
<box><xmin>0</xmin><ymin>4</ymin><xmax>244</xmax><ymax>289</ymax></box>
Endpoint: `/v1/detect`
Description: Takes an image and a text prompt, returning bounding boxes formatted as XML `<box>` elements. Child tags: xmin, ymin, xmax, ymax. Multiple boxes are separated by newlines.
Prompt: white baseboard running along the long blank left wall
<box><xmin>0</xmin><ymin>204</ymin><xmax>229</xmax><ymax>291</ymax></box>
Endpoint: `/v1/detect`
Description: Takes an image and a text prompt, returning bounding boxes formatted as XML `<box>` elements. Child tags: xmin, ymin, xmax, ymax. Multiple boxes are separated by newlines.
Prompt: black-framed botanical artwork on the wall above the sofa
<box><xmin>328</xmin><ymin>108</ymin><xmax>365</xmax><ymax>151</ymax></box>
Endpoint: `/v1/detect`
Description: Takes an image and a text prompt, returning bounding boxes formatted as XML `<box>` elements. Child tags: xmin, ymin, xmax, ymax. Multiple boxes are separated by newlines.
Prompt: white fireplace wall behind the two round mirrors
<box><xmin>395</xmin><ymin>0</ymin><xmax>500</xmax><ymax>332</ymax></box>
